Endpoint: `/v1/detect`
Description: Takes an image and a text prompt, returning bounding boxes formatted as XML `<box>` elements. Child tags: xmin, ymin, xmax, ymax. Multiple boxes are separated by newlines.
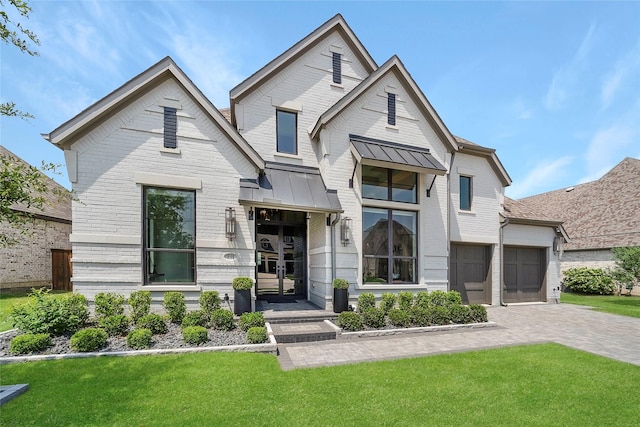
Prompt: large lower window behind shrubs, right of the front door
<box><xmin>362</xmin><ymin>207</ymin><xmax>418</xmax><ymax>284</ymax></box>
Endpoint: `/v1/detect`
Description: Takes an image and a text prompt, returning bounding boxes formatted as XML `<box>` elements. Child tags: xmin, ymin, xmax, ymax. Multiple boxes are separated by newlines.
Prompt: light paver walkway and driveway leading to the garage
<box><xmin>278</xmin><ymin>304</ymin><xmax>640</xmax><ymax>370</ymax></box>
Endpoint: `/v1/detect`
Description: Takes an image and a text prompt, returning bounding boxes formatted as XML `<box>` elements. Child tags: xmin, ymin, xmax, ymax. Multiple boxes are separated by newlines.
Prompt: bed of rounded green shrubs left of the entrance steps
<box><xmin>10</xmin><ymin>289</ymin><xmax>267</xmax><ymax>354</ymax></box>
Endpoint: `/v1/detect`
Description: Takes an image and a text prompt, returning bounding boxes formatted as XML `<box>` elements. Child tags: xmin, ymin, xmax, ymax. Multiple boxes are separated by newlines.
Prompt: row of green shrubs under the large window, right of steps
<box><xmin>338</xmin><ymin>291</ymin><xmax>487</xmax><ymax>331</ymax></box>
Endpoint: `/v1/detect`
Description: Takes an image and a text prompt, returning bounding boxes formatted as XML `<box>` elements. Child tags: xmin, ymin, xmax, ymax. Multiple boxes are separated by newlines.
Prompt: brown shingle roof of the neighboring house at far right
<box><xmin>519</xmin><ymin>157</ymin><xmax>640</xmax><ymax>250</ymax></box>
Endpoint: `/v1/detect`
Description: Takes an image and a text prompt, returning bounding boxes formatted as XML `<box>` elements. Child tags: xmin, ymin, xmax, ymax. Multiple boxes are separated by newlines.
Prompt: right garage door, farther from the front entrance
<box><xmin>503</xmin><ymin>247</ymin><xmax>546</xmax><ymax>303</ymax></box>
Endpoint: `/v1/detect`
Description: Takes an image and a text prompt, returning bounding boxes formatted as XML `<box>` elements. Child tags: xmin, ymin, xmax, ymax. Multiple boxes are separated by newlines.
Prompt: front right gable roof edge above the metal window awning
<box><xmin>310</xmin><ymin>55</ymin><xmax>458</xmax><ymax>151</ymax></box>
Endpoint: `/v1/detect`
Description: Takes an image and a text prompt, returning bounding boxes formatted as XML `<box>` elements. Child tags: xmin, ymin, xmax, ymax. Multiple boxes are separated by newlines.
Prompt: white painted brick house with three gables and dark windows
<box><xmin>45</xmin><ymin>15</ymin><xmax>558</xmax><ymax>308</ymax></box>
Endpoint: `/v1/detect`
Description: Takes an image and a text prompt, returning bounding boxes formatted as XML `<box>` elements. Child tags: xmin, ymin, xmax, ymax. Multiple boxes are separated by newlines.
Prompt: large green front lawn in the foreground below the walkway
<box><xmin>0</xmin><ymin>344</ymin><xmax>640</xmax><ymax>426</ymax></box>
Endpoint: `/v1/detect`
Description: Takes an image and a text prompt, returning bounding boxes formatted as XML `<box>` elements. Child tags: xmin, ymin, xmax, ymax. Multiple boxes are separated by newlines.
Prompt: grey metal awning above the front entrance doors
<box><xmin>240</xmin><ymin>162</ymin><xmax>342</xmax><ymax>212</ymax></box>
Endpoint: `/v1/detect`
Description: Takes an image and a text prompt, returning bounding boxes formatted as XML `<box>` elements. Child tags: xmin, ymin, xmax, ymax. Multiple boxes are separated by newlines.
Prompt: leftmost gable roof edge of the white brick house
<box><xmin>42</xmin><ymin>56</ymin><xmax>264</xmax><ymax>170</ymax></box>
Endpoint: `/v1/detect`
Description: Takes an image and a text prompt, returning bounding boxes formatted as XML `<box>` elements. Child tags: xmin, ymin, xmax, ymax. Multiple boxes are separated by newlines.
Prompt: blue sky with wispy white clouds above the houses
<box><xmin>0</xmin><ymin>1</ymin><xmax>640</xmax><ymax>198</ymax></box>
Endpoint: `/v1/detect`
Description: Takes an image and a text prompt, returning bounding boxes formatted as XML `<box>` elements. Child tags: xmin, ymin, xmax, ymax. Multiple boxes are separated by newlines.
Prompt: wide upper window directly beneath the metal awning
<box><xmin>362</xmin><ymin>165</ymin><xmax>418</xmax><ymax>203</ymax></box>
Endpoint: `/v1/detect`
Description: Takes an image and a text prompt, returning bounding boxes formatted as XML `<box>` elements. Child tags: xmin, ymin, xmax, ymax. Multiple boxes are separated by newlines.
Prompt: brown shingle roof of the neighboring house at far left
<box><xmin>0</xmin><ymin>145</ymin><xmax>71</xmax><ymax>224</ymax></box>
